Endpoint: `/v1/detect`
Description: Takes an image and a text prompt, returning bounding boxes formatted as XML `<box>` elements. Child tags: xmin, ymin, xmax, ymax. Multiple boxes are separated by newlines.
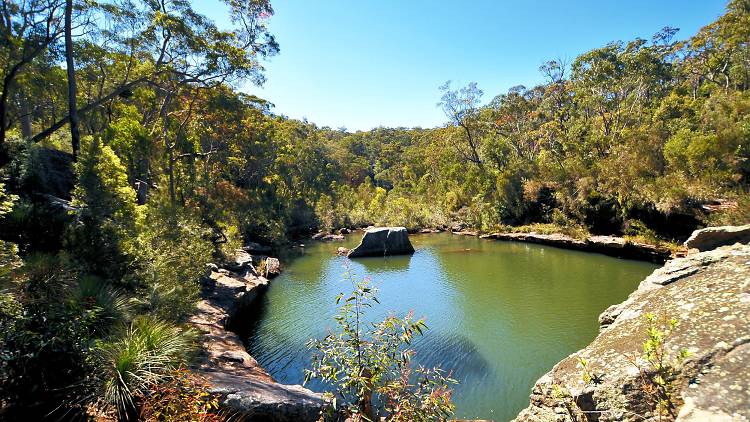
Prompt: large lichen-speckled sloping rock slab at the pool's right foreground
<box><xmin>516</xmin><ymin>244</ymin><xmax>750</xmax><ymax>422</ymax></box>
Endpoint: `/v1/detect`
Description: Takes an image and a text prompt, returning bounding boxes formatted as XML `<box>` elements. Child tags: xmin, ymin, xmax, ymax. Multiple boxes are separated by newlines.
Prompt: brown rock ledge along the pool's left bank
<box><xmin>189</xmin><ymin>270</ymin><xmax>324</xmax><ymax>421</ymax></box>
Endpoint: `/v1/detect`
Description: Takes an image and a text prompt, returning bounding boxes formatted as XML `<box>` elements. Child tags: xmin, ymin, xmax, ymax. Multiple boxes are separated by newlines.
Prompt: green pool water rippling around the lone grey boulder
<box><xmin>242</xmin><ymin>234</ymin><xmax>655</xmax><ymax>421</ymax></box>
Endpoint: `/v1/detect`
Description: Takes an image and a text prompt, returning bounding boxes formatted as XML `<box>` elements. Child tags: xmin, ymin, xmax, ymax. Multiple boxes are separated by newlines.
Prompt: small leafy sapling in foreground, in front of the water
<box><xmin>305</xmin><ymin>267</ymin><xmax>457</xmax><ymax>421</ymax></box>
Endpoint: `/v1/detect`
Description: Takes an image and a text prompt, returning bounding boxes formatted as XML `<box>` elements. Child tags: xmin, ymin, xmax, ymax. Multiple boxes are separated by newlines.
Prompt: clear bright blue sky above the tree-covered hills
<box><xmin>194</xmin><ymin>0</ymin><xmax>726</xmax><ymax>131</ymax></box>
